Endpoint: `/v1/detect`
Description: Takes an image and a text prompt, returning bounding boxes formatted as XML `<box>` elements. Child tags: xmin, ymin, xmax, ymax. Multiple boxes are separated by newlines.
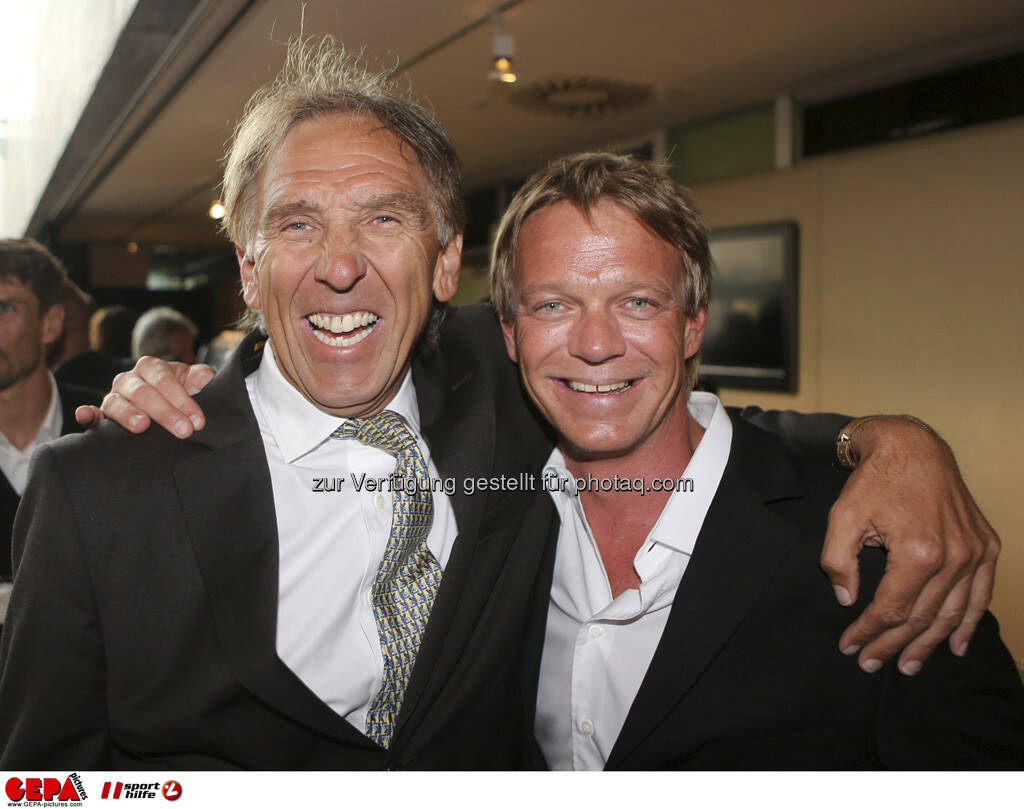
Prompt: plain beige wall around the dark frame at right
<box><xmin>694</xmin><ymin>119</ymin><xmax>1024</xmax><ymax>659</ymax></box>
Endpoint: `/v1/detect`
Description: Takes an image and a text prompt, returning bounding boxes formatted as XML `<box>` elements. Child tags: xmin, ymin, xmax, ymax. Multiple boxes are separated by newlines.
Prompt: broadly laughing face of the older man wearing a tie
<box><xmin>238</xmin><ymin>115</ymin><xmax>462</xmax><ymax>418</ymax></box>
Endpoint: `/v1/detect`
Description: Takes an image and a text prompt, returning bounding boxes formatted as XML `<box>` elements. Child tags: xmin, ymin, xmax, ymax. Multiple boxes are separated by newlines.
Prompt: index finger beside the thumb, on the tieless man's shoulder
<box><xmin>840</xmin><ymin>538</ymin><xmax>953</xmax><ymax>654</ymax></box>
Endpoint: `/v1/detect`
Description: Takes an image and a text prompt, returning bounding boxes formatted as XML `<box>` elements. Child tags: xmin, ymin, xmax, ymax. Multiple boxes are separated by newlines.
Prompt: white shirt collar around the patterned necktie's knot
<box><xmin>253</xmin><ymin>340</ymin><xmax>420</xmax><ymax>463</ymax></box>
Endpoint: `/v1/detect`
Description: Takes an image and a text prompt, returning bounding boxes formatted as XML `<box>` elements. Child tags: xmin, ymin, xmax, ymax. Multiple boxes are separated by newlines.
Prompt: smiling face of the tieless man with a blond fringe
<box><xmin>503</xmin><ymin>201</ymin><xmax>706</xmax><ymax>461</ymax></box>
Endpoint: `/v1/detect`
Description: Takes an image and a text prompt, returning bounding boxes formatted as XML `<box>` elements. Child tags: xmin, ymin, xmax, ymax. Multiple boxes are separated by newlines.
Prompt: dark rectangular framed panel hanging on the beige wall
<box><xmin>700</xmin><ymin>222</ymin><xmax>799</xmax><ymax>391</ymax></box>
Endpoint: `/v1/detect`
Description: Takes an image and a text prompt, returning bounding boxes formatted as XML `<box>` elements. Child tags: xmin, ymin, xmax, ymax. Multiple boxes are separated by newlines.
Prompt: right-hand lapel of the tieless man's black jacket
<box><xmin>606</xmin><ymin>419</ymin><xmax>801</xmax><ymax>769</ymax></box>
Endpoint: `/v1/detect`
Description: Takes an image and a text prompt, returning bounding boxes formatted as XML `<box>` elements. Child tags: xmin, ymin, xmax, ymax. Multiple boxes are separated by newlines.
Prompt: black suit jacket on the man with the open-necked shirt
<box><xmin>532</xmin><ymin>415</ymin><xmax>1024</xmax><ymax>770</ymax></box>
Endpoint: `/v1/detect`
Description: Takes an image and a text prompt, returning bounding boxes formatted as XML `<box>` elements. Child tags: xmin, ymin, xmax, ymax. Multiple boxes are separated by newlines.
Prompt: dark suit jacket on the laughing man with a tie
<box><xmin>0</xmin><ymin>308</ymin><xmax>550</xmax><ymax>770</ymax></box>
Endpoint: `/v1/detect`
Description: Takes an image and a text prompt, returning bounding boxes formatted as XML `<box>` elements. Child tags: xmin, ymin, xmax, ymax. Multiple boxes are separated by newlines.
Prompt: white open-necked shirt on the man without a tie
<box><xmin>536</xmin><ymin>393</ymin><xmax>732</xmax><ymax>770</ymax></box>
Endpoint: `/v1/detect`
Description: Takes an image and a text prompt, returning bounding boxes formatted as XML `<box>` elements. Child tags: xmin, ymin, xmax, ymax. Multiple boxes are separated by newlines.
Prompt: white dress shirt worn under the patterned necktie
<box><xmin>246</xmin><ymin>342</ymin><xmax>457</xmax><ymax>732</ymax></box>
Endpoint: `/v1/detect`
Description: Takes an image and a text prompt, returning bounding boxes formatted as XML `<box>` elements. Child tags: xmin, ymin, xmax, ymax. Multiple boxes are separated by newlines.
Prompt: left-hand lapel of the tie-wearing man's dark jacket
<box><xmin>174</xmin><ymin>336</ymin><xmax>376</xmax><ymax>749</ymax></box>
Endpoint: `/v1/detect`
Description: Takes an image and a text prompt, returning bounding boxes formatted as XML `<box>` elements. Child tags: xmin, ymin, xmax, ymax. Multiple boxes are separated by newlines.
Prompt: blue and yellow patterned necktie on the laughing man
<box><xmin>331</xmin><ymin>410</ymin><xmax>441</xmax><ymax>749</ymax></box>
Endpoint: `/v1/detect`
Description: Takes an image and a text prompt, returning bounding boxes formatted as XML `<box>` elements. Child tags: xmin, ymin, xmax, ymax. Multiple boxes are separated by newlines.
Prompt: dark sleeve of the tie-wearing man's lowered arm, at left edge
<box><xmin>0</xmin><ymin>446</ymin><xmax>112</xmax><ymax>770</ymax></box>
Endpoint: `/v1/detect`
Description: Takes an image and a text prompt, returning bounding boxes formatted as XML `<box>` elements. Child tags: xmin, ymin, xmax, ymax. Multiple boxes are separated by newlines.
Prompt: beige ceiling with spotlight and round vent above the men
<box><xmin>61</xmin><ymin>0</ymin><xmax>1024</xmax><ymax>246</ymax></box>
